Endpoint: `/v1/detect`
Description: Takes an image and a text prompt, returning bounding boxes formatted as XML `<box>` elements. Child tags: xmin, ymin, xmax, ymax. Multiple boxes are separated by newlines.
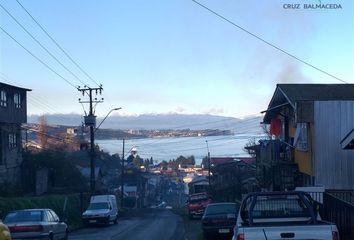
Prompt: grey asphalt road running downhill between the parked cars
<box><xmin>69</xmin><ymin>209</ymin><xmax>185</xmax><ymax>240</ymax></box>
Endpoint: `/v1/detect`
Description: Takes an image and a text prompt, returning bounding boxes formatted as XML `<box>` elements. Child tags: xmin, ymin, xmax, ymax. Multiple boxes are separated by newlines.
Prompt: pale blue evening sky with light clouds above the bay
<box><xmin>0</xmin><ymin>0</ymin><xmax>354</xmax><ymax>117</ymax></box>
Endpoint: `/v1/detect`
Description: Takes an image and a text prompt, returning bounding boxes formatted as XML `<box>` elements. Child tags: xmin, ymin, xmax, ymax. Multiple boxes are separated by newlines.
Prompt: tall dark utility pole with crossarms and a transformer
<box><xmin>78</xmin><ymin>85</ymin><xmax>103</xmax><ymax>194</ymax></box>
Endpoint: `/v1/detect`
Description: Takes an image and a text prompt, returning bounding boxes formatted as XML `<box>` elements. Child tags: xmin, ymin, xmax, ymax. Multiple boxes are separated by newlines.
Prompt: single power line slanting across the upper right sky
<box><xmin>191</xmin><ymin>0</ymin><xmax>348</xmax><ymax>83</ymax></box>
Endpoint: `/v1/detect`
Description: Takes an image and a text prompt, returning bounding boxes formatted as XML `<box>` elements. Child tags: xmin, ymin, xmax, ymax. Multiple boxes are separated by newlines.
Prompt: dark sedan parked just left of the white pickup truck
<box><xmin>202</xmin><ymin>202</ymin><xmax>240</xmax><ymax>239</ymax></box>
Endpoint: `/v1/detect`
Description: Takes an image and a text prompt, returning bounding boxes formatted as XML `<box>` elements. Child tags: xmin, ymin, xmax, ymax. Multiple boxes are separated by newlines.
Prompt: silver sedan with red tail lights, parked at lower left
<box><xmin>4</xmin><ymin>209</ymin><xmax>68</xmax><ymax>240</ymax></box>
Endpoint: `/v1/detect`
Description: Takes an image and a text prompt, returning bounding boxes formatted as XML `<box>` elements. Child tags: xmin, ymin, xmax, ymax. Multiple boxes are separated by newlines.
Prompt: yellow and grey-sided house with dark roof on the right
<box><xmin>253</xmin><ymin>84</ymin><xmax>354</xmax><ymax>190</ymax></box>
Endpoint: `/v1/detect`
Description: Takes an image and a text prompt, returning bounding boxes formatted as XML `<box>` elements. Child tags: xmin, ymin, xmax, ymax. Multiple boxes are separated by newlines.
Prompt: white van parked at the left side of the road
<box><xmin>82</xmin><ymin>195</ymin><xmax>118</xmax><ymax>225</ymax></box>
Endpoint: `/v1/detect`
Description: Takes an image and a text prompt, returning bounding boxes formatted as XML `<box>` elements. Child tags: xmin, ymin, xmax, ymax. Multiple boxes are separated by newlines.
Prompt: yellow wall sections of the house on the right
<box><xmin>289</xmin><ymin>118</ymin><xmax>314</xmax><ymax>175</ymax></box>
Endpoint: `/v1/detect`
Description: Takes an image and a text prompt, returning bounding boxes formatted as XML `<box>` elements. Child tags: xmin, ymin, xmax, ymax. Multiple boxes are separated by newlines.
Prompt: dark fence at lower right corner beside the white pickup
<box><xmin>320</xmin><ymin>191</ymin><xmax>354</xmax><ymax>240</ymax></box>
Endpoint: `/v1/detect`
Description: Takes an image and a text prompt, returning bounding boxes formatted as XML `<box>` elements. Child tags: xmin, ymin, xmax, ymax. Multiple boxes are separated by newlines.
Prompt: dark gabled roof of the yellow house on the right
<box><xmin>263</xmin><ymin>84</ymin><xmax>354</xmax><ymax>123</ymax></box>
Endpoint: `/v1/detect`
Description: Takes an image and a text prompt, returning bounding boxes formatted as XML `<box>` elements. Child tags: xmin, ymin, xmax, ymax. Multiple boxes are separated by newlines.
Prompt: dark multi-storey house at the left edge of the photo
<box><xmin>0</xmin><ymin>82</ymin><xmax>31</xmax><ymax>184</ymax></box>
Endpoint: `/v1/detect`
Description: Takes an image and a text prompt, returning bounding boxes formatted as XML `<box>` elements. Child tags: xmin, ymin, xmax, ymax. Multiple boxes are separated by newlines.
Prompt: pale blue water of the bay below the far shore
<box><xmin>96</xmin><ymin>134</ymin><xmax>263</xmax><ymax>164</ymax></box>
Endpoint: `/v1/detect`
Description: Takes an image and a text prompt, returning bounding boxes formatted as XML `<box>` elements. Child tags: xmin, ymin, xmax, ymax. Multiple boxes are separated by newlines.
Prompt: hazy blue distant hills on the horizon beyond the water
<box><xmin>28</xmin><ymin>114</ymin><xmax>263</xmax><ymax>134</ymax></box>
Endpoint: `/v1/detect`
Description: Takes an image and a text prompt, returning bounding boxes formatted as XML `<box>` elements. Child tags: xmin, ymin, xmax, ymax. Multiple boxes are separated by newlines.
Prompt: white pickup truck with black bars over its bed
<box><xmin>232</xmin><ymin>191</ymin><xmax>339</xmax><ymax>240</ymax></box>
